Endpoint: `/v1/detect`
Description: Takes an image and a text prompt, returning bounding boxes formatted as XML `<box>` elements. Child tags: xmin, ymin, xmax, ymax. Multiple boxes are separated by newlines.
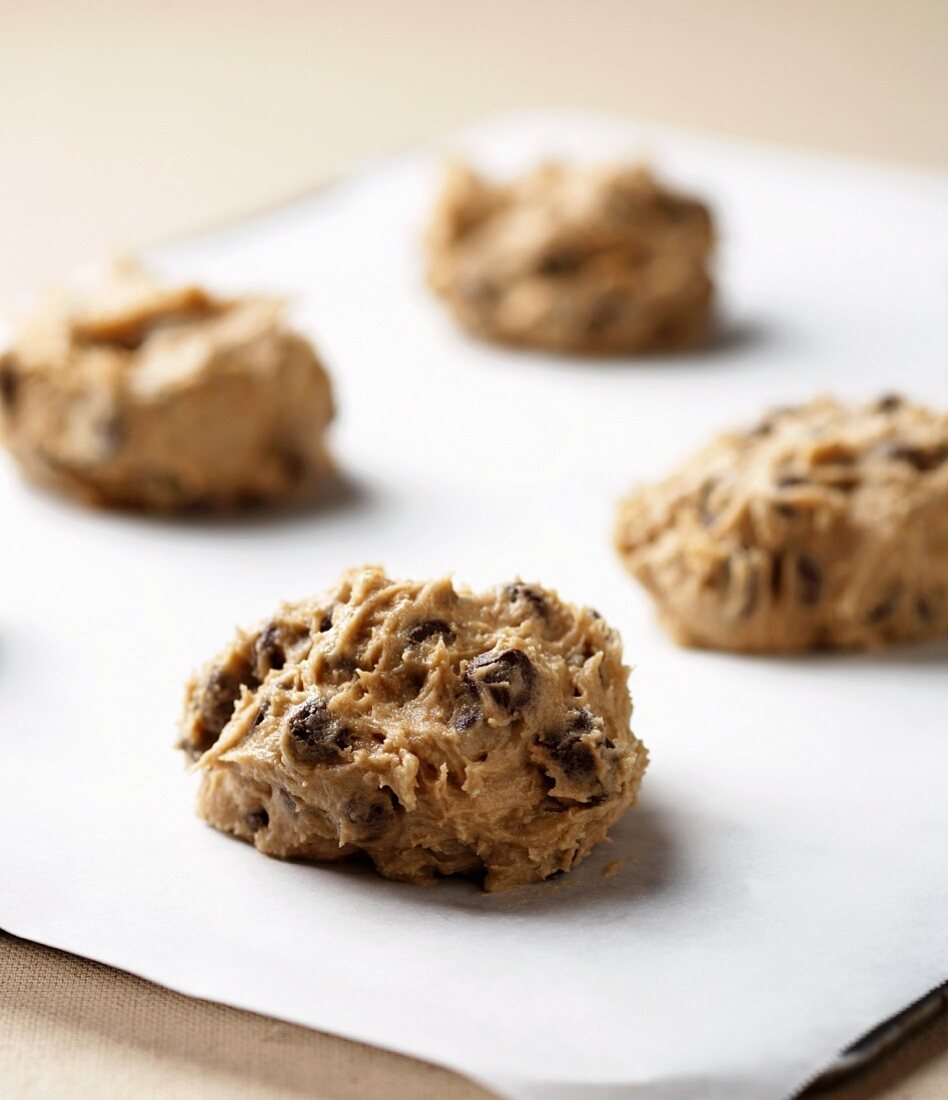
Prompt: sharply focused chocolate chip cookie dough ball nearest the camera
<box><xmin>181</xmin><ymin>568</ymin><xmax>647</xmax><ymax>890</ymax></box>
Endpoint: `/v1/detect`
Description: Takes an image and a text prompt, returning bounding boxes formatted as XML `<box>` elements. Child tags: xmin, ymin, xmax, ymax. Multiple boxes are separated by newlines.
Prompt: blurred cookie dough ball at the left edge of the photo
<box><xmin>0</xmin><ymin>264</ymin><xmax>332</xmax><ymax>510</ymax></box>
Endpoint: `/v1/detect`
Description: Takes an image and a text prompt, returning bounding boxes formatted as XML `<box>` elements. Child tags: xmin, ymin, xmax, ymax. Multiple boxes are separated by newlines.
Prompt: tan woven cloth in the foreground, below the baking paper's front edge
<box><xmin>0</xmin><ymin>934</ymin><xmax>948</xmax><ymax>1100</ymax></box>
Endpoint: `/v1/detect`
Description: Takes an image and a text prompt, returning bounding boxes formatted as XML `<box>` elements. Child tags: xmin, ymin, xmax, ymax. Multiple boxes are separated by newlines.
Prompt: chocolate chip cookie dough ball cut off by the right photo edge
<box><xmin>616</xmin><ymin>396</ymin><xmax>948</xmax><ymax>652</ymax></box>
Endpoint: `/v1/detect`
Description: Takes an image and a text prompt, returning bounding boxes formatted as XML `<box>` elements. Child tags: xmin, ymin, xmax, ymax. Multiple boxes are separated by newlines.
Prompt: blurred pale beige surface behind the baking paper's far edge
<box><xmin>0</xmin><ymin>0</ymin><xmax>948</xmax><ymax>296</ymax></box>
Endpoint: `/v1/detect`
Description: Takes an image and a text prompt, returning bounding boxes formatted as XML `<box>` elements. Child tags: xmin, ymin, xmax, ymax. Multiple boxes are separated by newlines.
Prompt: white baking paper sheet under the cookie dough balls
<box><xmin>0</xmin><ymin>114</ymin><xmax>948</xmax><ymax>1100</ymax></box>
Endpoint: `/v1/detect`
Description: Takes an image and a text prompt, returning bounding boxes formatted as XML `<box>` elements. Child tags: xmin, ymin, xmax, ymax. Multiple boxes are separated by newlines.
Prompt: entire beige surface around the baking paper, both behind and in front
<box><xmin>0</xmin><ymin>0</ymin><xmax>948</xmax><ymax>1100</ymax></box>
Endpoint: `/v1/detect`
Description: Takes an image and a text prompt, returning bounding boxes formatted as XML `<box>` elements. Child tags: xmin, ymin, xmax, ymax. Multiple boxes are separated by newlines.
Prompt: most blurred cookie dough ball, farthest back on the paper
<box><xmin>428</xmin><ymin>164</ymin><xmax>714</xmax><ymax>354</ymax></box>
